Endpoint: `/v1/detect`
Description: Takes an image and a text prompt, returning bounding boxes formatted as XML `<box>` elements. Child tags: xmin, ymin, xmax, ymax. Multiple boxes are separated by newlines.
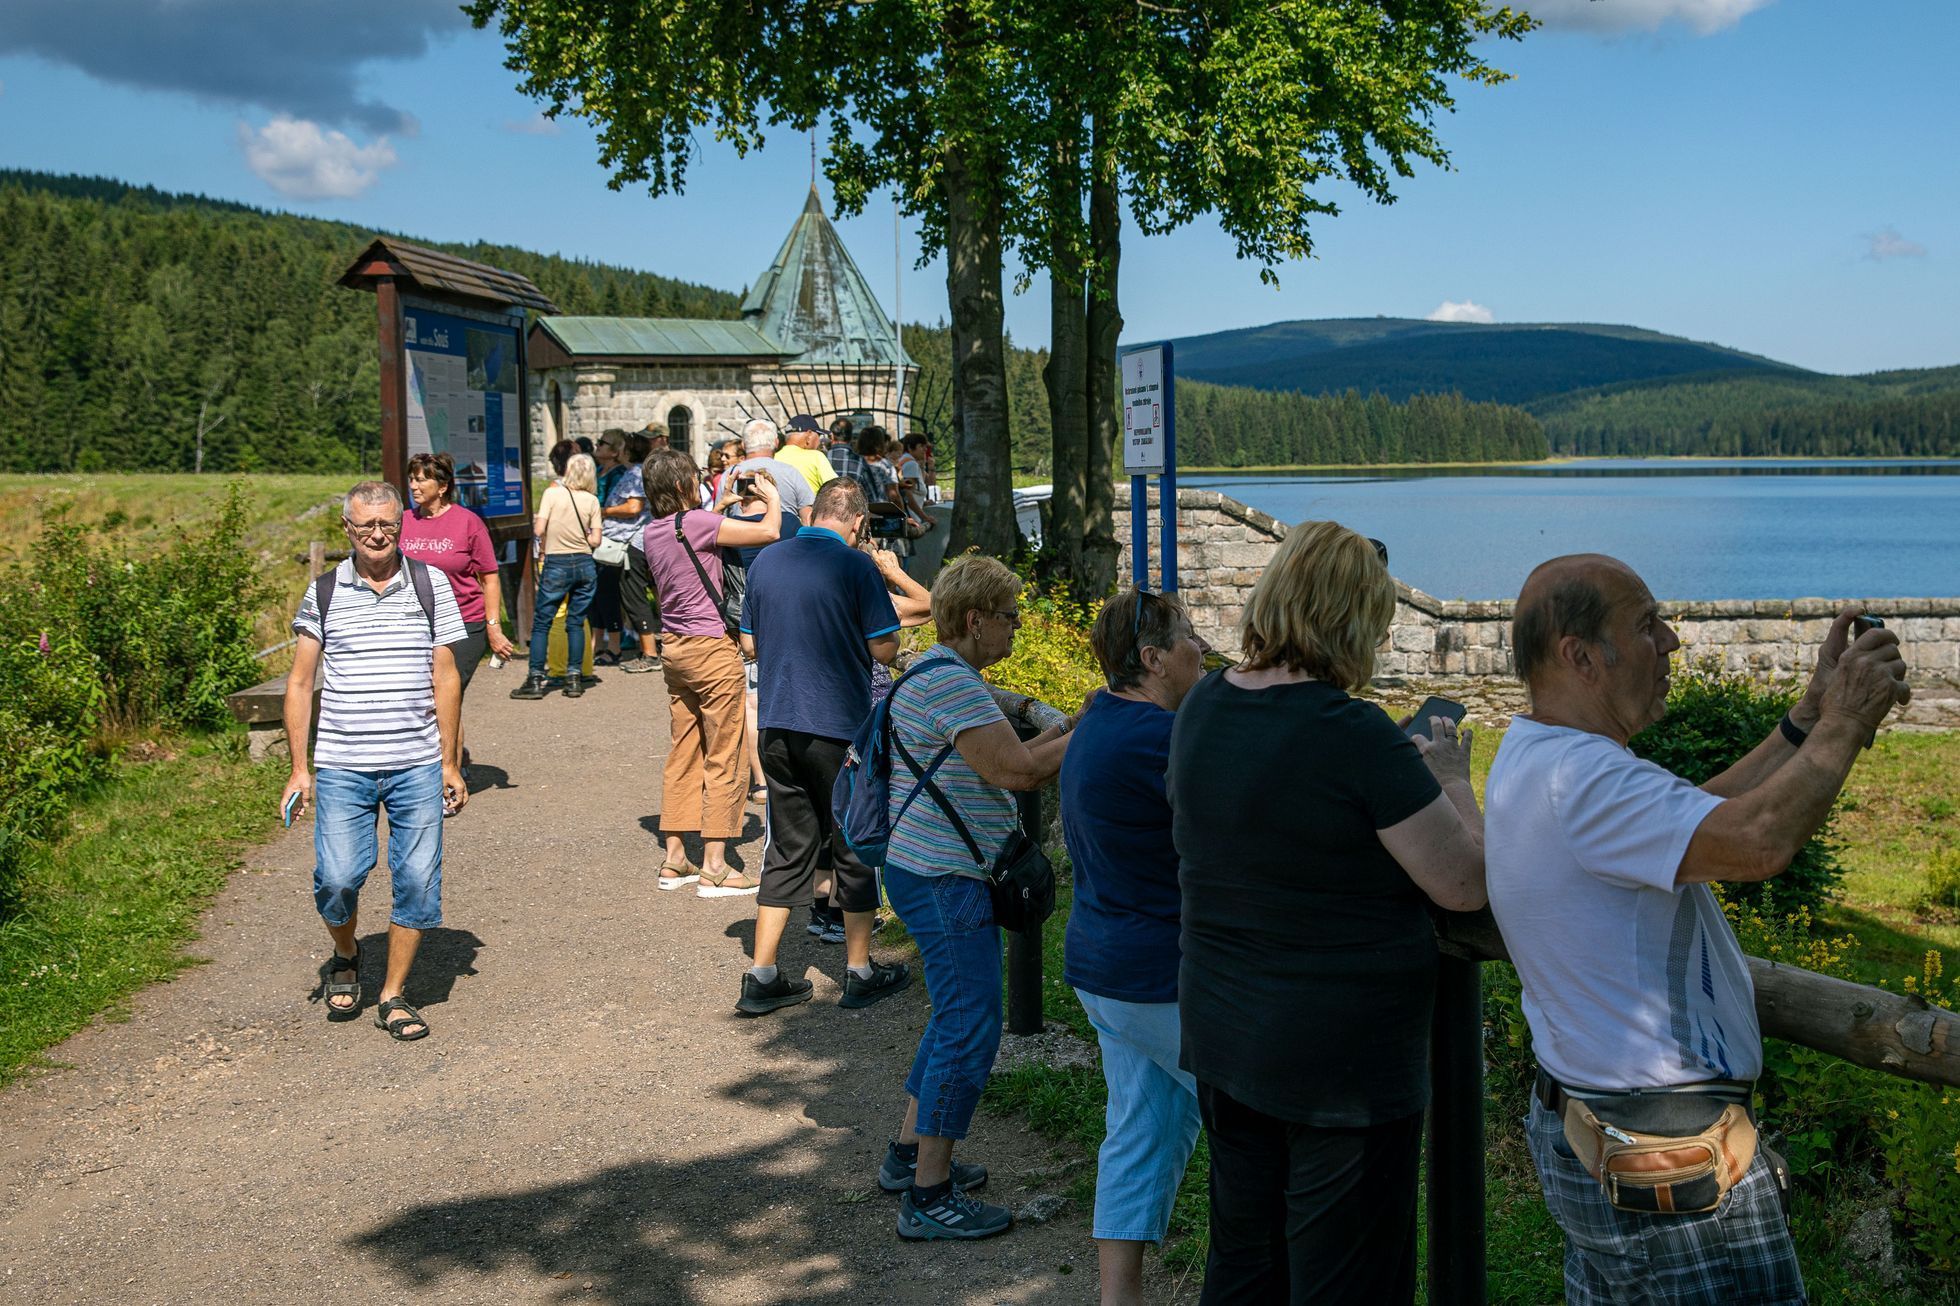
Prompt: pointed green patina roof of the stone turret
<box><xmin>741</xmin><ymin>186</ymin><xmax>911</xmax><ymax>367</ymax></box>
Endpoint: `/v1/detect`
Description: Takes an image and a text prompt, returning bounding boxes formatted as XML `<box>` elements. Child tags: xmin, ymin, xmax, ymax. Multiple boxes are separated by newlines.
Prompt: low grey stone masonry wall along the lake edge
<box><xmin>1115</xmin><ymin>490</ymin><xmax>1960</xmax><ymax>729</ymax></box>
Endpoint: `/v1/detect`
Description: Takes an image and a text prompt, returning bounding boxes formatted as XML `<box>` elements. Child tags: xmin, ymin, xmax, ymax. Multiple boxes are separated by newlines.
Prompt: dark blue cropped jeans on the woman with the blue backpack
<box><xmin>884</xmin><ymin>867</ymin><xmax>1000</xmax><ymax>1137</ymax></box>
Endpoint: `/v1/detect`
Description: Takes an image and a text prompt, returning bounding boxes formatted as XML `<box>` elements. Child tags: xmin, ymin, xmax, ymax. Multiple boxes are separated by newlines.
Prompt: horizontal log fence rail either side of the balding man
<box><xmin>1437</xmin><ymin>908</ymin><xmax>1960</xmax><ymax>1088</ymax></box>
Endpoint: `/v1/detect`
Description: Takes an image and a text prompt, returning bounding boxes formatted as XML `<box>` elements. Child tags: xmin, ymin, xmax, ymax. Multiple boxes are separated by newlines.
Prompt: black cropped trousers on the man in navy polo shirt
<box><xmin>757</xmin><ymin>726</ymin><xmax>878</xmax><ymax>912</ymax></box>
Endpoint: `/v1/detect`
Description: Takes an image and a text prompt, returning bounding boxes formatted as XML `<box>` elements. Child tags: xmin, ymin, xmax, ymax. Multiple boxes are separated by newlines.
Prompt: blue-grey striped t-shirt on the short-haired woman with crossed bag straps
<box><xmin>890</xmin><ymin>643</ymin><xmax>1021</xmax><ymax>875</ymax></box>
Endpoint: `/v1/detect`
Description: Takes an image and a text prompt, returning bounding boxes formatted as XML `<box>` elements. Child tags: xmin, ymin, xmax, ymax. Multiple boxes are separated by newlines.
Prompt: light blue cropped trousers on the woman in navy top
<box><xmin>1076</xmin><ymin>988</ymin><xmax>1198</xmax><ymax>1243</ymax></box>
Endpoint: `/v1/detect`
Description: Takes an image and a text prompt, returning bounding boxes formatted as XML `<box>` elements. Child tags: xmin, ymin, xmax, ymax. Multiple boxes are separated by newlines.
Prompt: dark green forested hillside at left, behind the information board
<box><xmin>0</xmin><ymin>171</ymin><xmax>739</xmax><ymax>471</ymax></box>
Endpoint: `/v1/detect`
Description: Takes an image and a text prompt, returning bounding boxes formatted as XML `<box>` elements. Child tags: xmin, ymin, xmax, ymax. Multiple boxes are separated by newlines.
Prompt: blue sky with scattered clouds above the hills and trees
<box><xmin>0</xmin><ymin>0</ymin><xmax>1960</xmax><ymax>373</ymax></box>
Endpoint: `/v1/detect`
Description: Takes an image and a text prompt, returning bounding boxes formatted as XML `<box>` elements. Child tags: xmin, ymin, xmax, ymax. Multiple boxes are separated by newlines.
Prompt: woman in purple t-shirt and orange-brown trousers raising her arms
<box><xmin>643</xmin><ymin>449</ymin><xmax>782</xmax><ymax>898</ymax></box>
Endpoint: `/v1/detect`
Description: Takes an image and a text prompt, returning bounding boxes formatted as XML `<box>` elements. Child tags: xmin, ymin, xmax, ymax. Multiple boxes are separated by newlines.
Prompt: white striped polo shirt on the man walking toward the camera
<box><xmin>292</xmin><ymin>559</ymin><xmax>466</xmax><ymax>771</ymax></box>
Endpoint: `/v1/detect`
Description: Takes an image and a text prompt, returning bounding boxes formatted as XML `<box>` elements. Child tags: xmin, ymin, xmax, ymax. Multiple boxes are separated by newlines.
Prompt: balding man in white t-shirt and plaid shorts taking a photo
<box><xmin>1484</xmin><ymin>553</ymin><xmax>1911</xmax><ymax>1306</ymax></box>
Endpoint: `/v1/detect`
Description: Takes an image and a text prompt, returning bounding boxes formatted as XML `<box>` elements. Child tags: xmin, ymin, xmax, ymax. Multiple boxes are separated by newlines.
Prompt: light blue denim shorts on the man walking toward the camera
<box><xmin>314</xmin><ymin>763</ymin><xmax>443</xmax><ymax>929</ymax></box>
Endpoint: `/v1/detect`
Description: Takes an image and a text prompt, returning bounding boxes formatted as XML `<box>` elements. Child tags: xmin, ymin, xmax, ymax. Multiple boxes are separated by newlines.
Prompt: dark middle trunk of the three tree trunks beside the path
<box><xmin>1041</xmin><ymin>113</ymin><xmax>1107</xmax><ymax>598</ymax></box>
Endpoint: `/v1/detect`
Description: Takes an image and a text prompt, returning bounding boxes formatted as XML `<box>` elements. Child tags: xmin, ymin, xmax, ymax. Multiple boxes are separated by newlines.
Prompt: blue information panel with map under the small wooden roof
<box><xmin>402</xmin><ymin>304</ymin><xmax>523</xmax><ymax>518</ymax></box>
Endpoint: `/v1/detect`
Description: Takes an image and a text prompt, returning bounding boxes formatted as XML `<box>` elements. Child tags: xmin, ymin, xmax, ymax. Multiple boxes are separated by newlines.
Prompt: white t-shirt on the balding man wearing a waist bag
<box><xmin>1484</xmin><ymin>718</ymin><xmax>1762</xmax><ymax>1088</ymax></box>
